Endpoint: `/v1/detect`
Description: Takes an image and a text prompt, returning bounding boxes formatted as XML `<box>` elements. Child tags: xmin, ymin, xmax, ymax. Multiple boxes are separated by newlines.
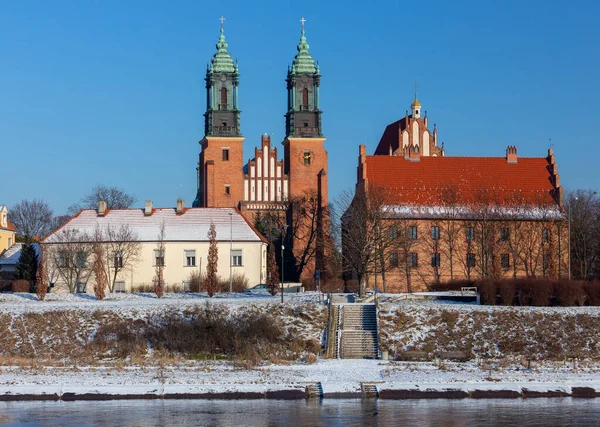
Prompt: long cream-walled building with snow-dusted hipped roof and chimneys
<box><xmin>42</xmin><ymin>201</ymin><xmax>267</xmax><ymax>292</ymax></box>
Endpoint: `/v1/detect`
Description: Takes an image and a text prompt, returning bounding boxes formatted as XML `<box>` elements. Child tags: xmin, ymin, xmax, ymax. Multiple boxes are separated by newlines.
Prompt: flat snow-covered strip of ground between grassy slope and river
<box><xmin>0</xmin><ymin>360</ymin><xmax>600</xmax><ymax>398</ymax></box>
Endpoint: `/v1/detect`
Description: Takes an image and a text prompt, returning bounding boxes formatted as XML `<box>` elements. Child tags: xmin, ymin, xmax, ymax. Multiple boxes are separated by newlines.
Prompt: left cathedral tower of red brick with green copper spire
<box><xmin>193</xmin><ymin>18</ymin><xmax>244</xmax><ymax>207</ymax></box>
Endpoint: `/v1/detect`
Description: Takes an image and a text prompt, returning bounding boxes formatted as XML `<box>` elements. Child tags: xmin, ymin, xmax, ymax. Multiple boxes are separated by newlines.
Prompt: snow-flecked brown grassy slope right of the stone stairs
<box><xmin>379</xmin><ymin>301</ymin><xmax>600</xmax><ymax>360</ymax></box>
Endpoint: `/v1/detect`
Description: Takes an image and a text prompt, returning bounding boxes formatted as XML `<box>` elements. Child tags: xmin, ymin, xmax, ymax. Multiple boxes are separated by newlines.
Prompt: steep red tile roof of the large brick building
<box><xmin>366</xmin><ymin>155</ymin><xmax>556</xmax><ymax>206</ymax></box>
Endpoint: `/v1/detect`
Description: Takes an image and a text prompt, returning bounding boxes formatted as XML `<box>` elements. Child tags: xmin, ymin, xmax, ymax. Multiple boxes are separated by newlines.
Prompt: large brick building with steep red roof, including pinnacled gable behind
<box><xmin>342</xmin><ymin>96</ymin><xmax>568</xmax><ymax>292</ymax></box>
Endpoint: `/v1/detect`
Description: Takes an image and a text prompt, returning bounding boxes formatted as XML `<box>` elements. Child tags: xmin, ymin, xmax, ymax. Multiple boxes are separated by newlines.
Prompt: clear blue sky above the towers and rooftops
<box><xmin>0</xmin><ymin>0</ymin><xmax>600</xmax><ymax>214</ymax></box>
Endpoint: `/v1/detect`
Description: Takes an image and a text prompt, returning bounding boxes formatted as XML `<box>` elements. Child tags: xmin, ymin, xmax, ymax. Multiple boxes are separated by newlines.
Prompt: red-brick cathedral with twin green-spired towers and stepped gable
<box><xmin>193</xmin><ymin>18</ymin><xmax>328</xmax><ymax>280</ymax></box>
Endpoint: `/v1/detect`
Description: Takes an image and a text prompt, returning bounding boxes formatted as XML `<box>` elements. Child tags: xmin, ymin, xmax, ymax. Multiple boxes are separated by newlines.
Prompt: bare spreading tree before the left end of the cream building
<box><xmin>43</xmin><ymin>229</ymin><xmax>93</xmax><ymax>293</ymax></box>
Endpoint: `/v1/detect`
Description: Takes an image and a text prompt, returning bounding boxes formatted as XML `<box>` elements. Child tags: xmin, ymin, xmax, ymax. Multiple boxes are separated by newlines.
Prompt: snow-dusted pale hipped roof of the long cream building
<box><xmin>44</xmin><ymin>208</ymin><xmax>264</xmax><ymax>243</ymax></box>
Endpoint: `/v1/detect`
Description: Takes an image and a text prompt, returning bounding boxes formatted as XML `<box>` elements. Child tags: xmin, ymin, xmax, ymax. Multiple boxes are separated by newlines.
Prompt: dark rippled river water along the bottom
<box><xmin>0</xmin><ymin>398</ymin><xmax>600</xmax><ymax>427</ymax></box>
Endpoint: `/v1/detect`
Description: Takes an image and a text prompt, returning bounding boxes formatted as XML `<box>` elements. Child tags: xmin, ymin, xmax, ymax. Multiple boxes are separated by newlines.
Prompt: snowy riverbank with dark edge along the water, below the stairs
<box><xmin>0</xmin><ymin>360</ymin><xmax>600</xmax><ymax>401</ymax></box>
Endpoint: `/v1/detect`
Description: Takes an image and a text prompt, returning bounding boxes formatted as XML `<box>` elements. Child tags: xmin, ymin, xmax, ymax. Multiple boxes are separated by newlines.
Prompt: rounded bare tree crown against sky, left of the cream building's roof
<box><xmin>8</xmin><ymin>199</ymin><xmax>54</xmax><ymax>239</ymax></box>
